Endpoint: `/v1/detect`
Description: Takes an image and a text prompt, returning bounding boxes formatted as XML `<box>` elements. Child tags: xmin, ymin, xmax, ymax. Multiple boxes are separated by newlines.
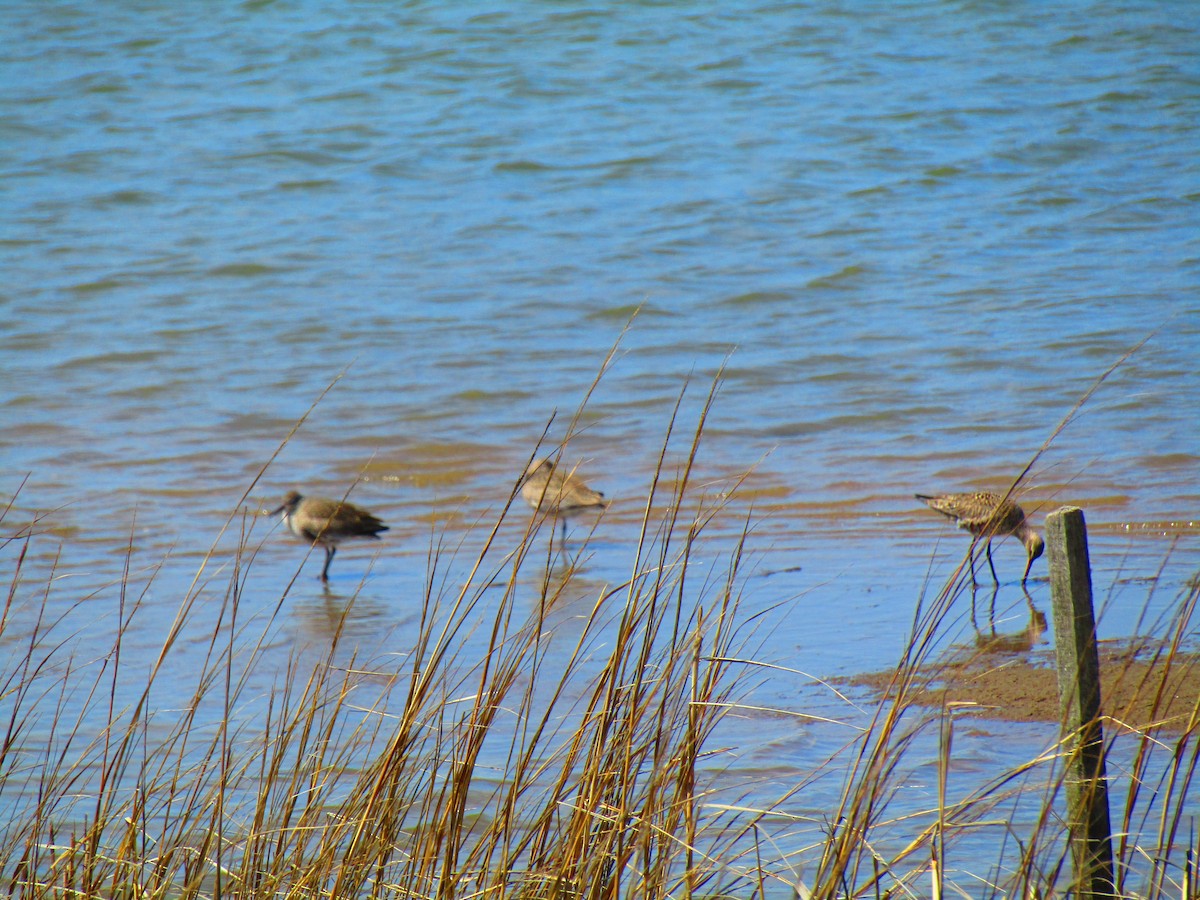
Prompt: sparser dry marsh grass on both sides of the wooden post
<box><xmin>785</xmin><ymin>547</ymin><xmax>1200</xmax><ymax>900</ymax></box>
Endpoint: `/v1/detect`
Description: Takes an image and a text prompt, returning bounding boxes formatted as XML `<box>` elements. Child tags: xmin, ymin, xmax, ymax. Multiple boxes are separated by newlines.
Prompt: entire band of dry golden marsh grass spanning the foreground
<box><xmin>0</xmin><ymin>358</ymin><xmax>1200</xmax><ymax>900</ymax></box>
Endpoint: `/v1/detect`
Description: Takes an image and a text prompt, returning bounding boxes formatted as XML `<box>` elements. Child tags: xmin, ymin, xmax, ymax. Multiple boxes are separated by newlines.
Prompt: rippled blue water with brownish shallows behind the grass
<box><xmin>0</xmin><ymin>0</ymin><xmax>1200</xmax><ymax>888</ymax></box>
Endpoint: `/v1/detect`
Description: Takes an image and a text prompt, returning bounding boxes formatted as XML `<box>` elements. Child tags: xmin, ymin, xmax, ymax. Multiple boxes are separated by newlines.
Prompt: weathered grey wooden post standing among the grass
<box><xmin>1046</xmin><ymin>506</ymin><xmax>1117</xmax><ymax>900</ymax></box>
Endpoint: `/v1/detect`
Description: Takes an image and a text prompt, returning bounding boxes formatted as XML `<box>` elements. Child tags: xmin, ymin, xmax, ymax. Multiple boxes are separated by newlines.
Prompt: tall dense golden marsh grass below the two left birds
<box><xmin>0</xmin><ymin>362</ymin><xmax>768</xmax><ymax>898</ymax></box>
